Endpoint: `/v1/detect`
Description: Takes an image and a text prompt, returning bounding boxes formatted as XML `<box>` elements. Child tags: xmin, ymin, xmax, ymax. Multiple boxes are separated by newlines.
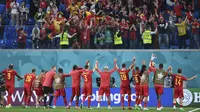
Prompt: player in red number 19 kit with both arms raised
<box><xmin>116</xmin><ymin>57</ymin><xmax>135</xmax><ymax>110</ymax></box>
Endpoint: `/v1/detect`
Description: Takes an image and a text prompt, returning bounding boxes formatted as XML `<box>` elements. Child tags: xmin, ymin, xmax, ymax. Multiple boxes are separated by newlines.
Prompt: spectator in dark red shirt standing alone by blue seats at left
<box><xmin>17</xmin><ymin>27</ymin><xmax>28</xmax><ymax>49</ymax></box>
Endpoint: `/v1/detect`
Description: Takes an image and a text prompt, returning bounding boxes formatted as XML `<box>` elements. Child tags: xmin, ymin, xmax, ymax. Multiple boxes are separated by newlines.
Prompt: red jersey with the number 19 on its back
<box><xmin>117</xmin><ymin>69</ymin><xmax>130</xmax><ymax>87</ymax></box>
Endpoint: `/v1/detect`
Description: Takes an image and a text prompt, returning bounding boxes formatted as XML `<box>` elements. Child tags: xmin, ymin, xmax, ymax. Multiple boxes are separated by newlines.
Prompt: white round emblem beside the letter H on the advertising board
<box><xmin>177</xmin><ymin>89</ymin><xmax>193</xmax><ymax>106</ymax></box>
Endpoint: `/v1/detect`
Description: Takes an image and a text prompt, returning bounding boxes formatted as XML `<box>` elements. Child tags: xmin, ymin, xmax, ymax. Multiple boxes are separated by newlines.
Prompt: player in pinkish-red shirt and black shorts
<box><xmin>43</xmin><ymin>66</ymin><xmax>56</xmax><ymax>108</ymax></box>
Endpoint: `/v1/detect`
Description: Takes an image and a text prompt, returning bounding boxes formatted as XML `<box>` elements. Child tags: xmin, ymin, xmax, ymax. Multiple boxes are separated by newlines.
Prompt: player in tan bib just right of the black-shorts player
<box><xmin>53</xmin><ymin>68</ymin><xmax>70</xmax><ymax>109</ymax></box>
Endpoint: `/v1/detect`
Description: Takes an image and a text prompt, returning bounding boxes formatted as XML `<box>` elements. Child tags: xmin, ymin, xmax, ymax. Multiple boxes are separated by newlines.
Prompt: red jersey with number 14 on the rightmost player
<box><xmin>172</xmin><ymin>74</ymin><xmax>187</xmax><ymax>88</ymax></box>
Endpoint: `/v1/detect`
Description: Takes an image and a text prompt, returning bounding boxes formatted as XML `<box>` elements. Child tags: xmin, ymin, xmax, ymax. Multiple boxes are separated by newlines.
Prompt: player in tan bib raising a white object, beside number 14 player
<box><xmin>149</xmin><ymin>54</ymin><xmax>171</xmax><ymax>110</ymax></box>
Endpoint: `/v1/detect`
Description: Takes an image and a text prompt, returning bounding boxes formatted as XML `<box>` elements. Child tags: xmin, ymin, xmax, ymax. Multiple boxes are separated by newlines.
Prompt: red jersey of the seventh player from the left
<box><xmin>82</xmin><ymin>70</ymin><xmax>93</xmax><ymax>86</ymax></box>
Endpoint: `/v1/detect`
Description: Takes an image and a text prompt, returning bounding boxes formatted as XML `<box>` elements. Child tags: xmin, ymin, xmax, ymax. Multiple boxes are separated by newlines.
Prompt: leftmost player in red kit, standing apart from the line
<box><xmin>2</xmin><ymin>64</ymin><xmax>23</xmax><ymax>108</ymax></box>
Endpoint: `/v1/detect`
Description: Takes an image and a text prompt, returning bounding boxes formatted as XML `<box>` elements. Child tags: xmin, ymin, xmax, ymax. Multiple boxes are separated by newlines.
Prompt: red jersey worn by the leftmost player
<box><xmin>2</xmin><ymin>69</ymin><xmax>17</xmax><ymax>85</ymax></box>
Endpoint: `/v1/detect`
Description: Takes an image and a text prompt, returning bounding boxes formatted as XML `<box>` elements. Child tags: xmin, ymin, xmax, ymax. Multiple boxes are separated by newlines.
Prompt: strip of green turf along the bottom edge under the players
<box><xmin>0</xmin><ymin>107</ymin><xmax>198</xmax><ymax>112</ymax></box>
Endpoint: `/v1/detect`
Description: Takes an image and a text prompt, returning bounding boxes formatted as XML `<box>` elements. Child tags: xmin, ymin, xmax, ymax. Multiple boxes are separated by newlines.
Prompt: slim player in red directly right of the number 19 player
<box><xmin>132</xmin><ymin>67</ymin><xmax>141</xmax><ymax>108</ymax></box>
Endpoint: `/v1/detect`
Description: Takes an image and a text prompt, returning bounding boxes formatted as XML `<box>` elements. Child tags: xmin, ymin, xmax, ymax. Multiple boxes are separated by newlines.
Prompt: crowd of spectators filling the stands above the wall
<box><xmin>0</xmin><ymin>0</ymin><xmax>200</xmax><ymax>49</ymax></box>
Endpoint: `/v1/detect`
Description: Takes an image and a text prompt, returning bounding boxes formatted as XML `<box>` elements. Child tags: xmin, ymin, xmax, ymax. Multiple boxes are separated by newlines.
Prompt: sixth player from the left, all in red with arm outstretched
<box><xmin>67</xmin><ymin>61</ymin><xmax>89</xmax><ymax>109</ymax></box>
